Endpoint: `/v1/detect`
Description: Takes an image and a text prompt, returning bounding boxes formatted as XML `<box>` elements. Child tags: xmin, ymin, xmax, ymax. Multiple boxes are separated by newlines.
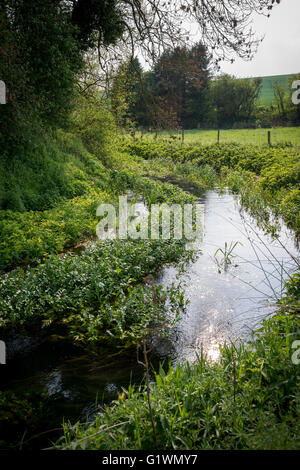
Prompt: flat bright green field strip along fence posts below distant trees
<box><xmin>136</xmin><ymin>127</ymin><xmax>300</xmax><ymax>146</ymax></box>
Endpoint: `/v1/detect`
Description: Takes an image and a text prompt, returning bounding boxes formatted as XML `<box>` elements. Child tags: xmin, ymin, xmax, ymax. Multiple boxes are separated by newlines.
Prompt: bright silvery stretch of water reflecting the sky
<box><xmin>158</xmin><ymin>191</ymin><xmax>299</xmax><ymax>362</ymax></box>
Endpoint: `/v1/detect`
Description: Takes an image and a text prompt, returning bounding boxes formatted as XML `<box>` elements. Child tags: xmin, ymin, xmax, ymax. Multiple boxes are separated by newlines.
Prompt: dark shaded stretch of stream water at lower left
<box><xmin>0</xmin><ymin>338</ymin><xmax>149</xmax><ymax>422</ymax></box>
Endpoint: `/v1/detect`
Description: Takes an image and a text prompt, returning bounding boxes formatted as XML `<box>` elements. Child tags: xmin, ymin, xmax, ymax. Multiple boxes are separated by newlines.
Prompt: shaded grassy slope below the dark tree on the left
<box><xmin>0</xmin><ymin>132</ymin><xmax>110</xmax><ymax>213</ymax></box>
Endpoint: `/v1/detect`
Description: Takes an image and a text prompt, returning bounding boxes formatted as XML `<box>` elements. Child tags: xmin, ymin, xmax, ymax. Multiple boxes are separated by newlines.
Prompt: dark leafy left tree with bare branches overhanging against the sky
<box><xmin>0</xmin><ymin>0</ymin><xmax>279</xmax><ymax>155</ymax></box>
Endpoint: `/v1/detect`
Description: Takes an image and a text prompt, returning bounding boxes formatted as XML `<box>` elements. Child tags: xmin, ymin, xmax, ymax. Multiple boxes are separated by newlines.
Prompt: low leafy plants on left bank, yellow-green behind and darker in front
<box><xmin>0</xmin><ymin>158</ymin><xmax>194</xmax><ymax>342</ymax></box>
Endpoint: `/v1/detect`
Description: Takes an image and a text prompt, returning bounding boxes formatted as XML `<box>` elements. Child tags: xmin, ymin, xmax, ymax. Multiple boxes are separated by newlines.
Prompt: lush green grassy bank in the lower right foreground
<box><xmin>56</xmin><ymin>274</ymin><xmax>300</xmax><ymax>450</ymax></box>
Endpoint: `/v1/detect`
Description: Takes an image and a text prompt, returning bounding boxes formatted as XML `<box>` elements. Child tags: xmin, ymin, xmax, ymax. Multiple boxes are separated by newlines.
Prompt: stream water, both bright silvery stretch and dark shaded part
<box><xmin>1</xmin><ymin>181</ymin><xmax>299</xmax><ymax>446</ymax></box>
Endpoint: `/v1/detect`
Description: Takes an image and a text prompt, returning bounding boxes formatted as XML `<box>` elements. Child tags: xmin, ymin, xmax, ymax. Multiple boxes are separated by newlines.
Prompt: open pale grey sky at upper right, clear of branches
<box><xmin>221</xmin><ymin>0</ymin><xmax>300</xmax><ymax>77</ymax></box>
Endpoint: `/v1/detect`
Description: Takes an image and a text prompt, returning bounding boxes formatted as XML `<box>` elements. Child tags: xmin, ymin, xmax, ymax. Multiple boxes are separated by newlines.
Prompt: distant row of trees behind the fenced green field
<box><xmin>109</xmin><ymin>50</ymin><xmax>300</xmax><ymax>130</ymax></box>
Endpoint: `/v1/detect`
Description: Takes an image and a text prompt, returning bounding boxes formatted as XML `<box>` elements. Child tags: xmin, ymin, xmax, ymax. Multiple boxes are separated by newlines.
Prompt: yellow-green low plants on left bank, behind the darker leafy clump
<box><xmin>0</xmin><ymin>140</ymin><xmax>197</xmax><ymax>271</ymax></box>
